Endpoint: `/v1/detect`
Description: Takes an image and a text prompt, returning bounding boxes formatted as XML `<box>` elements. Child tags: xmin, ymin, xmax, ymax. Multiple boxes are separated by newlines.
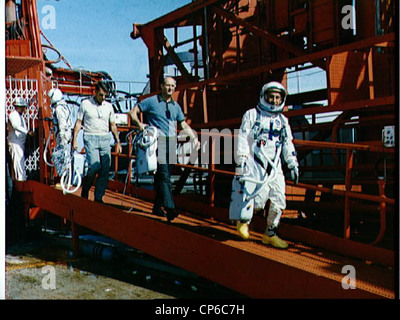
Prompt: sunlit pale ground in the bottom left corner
<box><xmin>5</xmin><ymin>245</ymin><xmax>174</xmax><ymax>300</ymax></box>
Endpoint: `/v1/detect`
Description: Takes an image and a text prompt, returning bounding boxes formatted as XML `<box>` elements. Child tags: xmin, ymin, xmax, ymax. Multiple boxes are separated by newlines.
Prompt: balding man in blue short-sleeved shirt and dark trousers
<box><xmin>129</xmin><ymin>77</ymin><xmax>200</xmax><ymax>221</ymax></box>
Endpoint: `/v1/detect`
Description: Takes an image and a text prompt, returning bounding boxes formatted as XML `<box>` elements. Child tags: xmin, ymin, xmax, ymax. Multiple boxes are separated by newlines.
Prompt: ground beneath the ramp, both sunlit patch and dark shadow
<box><xmin>5</xmin><ymin>232</ymin><xmax>244</xmax><ymax>300</ymax></box>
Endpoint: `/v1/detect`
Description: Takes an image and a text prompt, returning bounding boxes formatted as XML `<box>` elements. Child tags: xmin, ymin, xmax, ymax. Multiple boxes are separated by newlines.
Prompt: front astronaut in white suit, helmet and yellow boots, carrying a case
<box><xmin>229</xmin><ymin>82</ymin><xmax>299</xmax><ymax>249</ymax></box>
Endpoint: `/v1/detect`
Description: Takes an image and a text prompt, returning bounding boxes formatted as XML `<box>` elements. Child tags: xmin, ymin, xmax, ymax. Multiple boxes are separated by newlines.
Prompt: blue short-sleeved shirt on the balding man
<box><xmin>138</xmin><ymin>95</ymin><xmax>185</xmax><ymax>137</ymax></box>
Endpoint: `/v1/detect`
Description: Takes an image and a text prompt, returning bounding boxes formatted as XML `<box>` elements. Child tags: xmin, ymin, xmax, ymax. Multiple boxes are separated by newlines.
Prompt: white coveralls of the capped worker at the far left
<box><xmin>7</xmin><ymin>110</ymin><xmax>29</xmax><ymax>181</ymax></box>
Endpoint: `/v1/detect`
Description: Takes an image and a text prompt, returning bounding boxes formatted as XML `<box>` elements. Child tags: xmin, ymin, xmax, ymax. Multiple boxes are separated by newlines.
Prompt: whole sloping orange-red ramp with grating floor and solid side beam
<box><xmin>14</xmin><ymin>181</ymin><xmax>395</xmax><ymax>299</ymax></box>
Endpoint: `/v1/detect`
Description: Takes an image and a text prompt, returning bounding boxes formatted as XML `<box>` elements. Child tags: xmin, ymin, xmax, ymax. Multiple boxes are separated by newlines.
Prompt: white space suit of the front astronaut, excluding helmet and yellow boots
<box><xmin>236</xmin><ymin>107</ymin><xmax>298</xmax><ymax>228</ymax></box>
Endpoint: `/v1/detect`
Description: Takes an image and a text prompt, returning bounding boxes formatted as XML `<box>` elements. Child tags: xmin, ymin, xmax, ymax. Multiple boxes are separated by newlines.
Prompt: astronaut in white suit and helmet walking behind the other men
<box><xmin>48</xmin><ymin>88</ymin><xmax>74</xmax><ymax>176</ymax></box>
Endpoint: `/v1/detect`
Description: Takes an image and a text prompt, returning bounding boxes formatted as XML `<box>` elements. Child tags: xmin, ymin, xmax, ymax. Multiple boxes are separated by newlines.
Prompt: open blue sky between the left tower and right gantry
<box><xmin>37</xmin><ymin>0</ymin><xmax>191</xmax><ymax>92</ymax></box>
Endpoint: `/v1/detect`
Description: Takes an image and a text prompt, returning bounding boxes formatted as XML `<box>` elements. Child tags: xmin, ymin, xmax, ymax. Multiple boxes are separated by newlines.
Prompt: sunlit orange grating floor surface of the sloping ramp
<box><xmin>109</xmin><ymin>192</ymin><xmax>394</xmax><ymax>298</ymax></box>
